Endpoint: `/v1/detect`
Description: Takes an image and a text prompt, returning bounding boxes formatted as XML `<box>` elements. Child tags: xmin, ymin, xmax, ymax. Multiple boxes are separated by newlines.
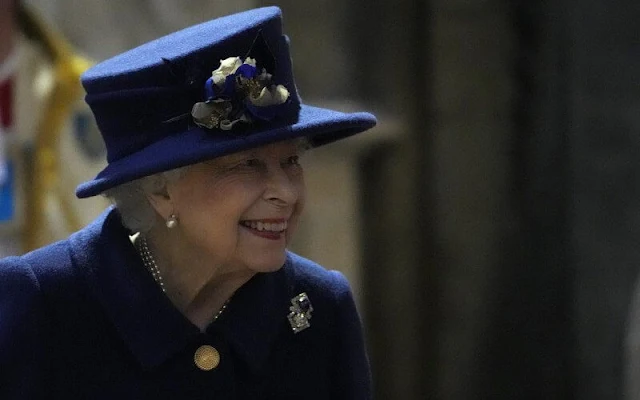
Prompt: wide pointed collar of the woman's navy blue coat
<box><xmin>71</xmin><ymin>208</ymin><xmax>291</xmax><ymax>372</ymax></box>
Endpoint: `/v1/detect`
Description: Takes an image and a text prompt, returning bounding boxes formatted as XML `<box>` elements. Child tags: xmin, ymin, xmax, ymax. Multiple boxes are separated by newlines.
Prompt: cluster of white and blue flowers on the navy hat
<box><xmin>191</xmin><ymin>57</ymin><xmax>289</xmax><ymax>131</ymax></box>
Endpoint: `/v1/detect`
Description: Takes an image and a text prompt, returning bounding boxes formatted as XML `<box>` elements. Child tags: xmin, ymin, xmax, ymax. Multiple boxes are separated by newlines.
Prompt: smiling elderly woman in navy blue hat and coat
<box><xmin>0</xmin><ymin>7</ymin><xmax>375</xmax><ymax>400</ymax></box>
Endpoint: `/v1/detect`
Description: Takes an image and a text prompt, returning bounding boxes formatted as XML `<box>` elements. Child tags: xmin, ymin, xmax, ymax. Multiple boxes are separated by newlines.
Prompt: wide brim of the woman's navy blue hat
<box><xmin>76</xmin><ymin>104</ymin><xmax>376</xmax><ymax>198</ymax></box>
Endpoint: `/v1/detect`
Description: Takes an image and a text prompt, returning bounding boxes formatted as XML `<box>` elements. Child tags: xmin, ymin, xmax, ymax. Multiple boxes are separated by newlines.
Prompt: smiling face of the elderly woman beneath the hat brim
<box><xmin>168</xmin><ymin>141</ymin><xmax>305</xmax><ymax>272</ymax></box>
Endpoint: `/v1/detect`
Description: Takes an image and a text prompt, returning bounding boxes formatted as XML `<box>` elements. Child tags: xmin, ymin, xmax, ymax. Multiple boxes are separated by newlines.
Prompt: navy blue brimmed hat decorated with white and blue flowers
<box><xmin>76</xmin><ymin>7</ymin><xmax>376</xmax><ymax>198</ymax></box>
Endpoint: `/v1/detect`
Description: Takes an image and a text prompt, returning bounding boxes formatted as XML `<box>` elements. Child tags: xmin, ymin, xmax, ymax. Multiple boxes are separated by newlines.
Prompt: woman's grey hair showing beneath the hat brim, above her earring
<box><xmin>103</xmin><ymin>167</ymin><xmax>186</xmax><ymax>233</ymax></box>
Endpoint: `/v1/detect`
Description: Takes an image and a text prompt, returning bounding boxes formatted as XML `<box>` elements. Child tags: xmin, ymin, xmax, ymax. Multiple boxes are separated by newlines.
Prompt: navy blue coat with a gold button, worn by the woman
<box><xmin>0</xmin><ymin>210</ymin><xmax>371</xmax><ymax>400</ymax></box>
